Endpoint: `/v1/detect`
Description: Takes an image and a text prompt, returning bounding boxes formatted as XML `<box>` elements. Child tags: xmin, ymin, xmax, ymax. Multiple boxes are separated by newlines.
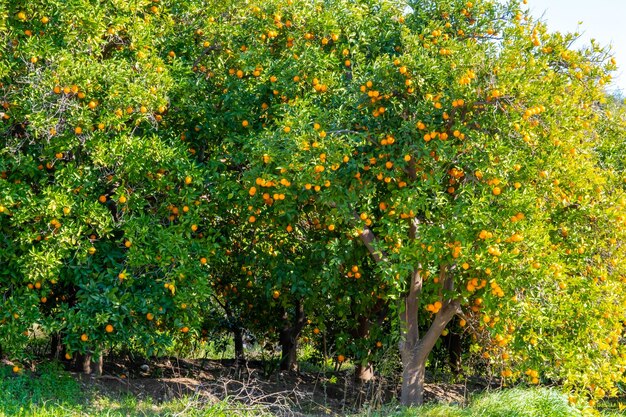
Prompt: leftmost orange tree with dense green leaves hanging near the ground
<box><xmin>0</xmin><ymin>1</ymin><xmax>218</xmax><ymax>364</ymax></box>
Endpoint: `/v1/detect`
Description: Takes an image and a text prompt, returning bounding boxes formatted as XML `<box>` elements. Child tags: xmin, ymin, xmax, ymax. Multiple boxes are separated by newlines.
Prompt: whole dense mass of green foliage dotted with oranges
<box><xmin>0</xmin><ymin>0</ymin><xmax>626</xmax><ymax>403</ymax></box>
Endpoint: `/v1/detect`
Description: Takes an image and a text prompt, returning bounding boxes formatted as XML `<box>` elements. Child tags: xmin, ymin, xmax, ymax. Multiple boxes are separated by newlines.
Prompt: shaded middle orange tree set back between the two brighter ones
<box><xmin>154</xmin><ymin>3</ymin><xmax>392</xmax><ymax>369</ymax></box>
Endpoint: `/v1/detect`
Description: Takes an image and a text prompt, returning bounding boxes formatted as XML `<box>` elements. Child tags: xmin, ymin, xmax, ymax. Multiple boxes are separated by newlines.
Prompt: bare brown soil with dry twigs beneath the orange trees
<box><xmin>74</xmin><ymin>358</ymin><xmax>485</xmax><ymax>416</ymax></box>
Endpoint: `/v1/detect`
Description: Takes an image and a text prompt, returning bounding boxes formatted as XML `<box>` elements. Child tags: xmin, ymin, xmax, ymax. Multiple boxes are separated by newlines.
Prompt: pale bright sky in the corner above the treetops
<box><xmin>527</xmin><ymin>0</ymin><xmax>626</xmax><ymax>93</ymax></box>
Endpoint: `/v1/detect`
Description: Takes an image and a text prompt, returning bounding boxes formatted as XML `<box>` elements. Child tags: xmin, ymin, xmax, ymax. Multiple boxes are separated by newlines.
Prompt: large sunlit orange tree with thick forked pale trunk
<box><xmin>182</xmin><ymin>0</ymin><xmax>624</xmax><ymax>404</ymax></box>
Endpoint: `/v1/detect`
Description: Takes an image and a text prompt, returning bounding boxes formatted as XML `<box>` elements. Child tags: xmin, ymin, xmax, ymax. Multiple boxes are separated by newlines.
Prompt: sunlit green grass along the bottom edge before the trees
<box><xmin>0</xmin><ymin>364</ymin><xmax>626</xmax><ymax>417</ymax></box>
